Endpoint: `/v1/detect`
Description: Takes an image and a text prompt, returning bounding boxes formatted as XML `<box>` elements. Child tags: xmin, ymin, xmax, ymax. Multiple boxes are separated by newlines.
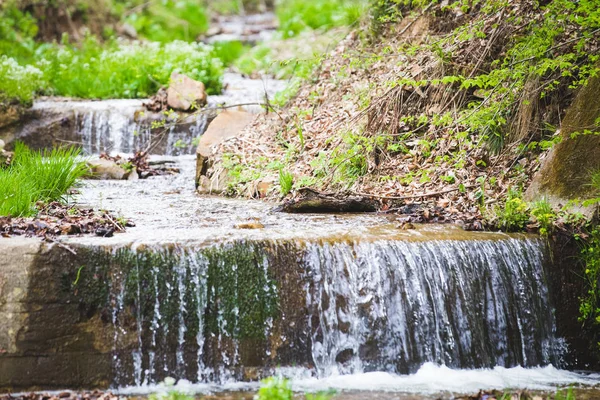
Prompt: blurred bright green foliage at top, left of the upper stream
<box><xmin>125</xmin><ymin>0</ymin><xmax>208</xmax><ymax>43</ymax></box>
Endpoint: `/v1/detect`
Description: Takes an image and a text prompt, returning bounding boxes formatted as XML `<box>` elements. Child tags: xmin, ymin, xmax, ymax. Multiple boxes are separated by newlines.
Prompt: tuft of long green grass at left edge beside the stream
<box><xmin>0</xmin><ymin>143</ymin><xmax>87</xmax><ymax>217</ymax></box>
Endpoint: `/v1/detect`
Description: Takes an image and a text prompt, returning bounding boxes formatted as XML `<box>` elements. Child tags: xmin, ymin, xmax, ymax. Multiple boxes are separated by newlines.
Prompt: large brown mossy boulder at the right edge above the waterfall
<box><xmin>525</xmin><ymin>65</ymin><xmax>600</xmax><ymax>217</ymax></box>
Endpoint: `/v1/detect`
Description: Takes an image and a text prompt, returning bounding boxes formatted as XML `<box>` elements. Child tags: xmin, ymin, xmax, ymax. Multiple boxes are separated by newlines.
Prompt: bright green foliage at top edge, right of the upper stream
<box><xmin>276</xmin><ymin>0</ymin><xmax>366</xmax><ymax>37</ymax></box>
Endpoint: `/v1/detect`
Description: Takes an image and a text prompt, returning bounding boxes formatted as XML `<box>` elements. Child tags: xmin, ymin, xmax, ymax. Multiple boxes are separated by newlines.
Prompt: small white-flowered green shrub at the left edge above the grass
<box><xmin>0</xmin><ymin>56</ymin><xmax>45</xmax><ymax>104</ymax></box>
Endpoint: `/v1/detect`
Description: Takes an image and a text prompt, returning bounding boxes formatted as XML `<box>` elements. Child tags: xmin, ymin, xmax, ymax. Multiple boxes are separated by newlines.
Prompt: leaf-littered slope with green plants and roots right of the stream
<box><xmin>211</xmin><ymin>0</ymin><xmax>600</xmax><ymax>225</ymax></box>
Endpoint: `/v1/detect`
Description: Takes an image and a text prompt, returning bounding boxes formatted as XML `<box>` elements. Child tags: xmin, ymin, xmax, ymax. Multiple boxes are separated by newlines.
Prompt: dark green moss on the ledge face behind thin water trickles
<box><xmin>62</xmin><ymin>243</ymin><xmax>278</xmax><ymax>340</ymax></box>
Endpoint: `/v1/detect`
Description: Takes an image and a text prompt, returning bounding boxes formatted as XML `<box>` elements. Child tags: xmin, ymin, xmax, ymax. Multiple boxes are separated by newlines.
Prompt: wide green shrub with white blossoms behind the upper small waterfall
<box><xmin>36</xmin><ymin>37</ymin><xmax>223</xmax><ymax>99</ymax></box>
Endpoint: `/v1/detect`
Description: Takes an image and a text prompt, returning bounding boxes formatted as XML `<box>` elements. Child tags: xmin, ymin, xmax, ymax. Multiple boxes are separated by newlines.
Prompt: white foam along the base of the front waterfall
<box><xmin>118</xmin><ymin>363</ymin><xmax>600</xmax><ymax>395</ymax></box>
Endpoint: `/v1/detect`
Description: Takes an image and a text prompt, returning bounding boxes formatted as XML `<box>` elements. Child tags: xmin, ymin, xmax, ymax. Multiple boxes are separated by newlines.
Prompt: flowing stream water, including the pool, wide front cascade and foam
<box><xmin>47</xmin><ymin>73</ymin><xmax>600</xmax><ymax>399</ymax></box>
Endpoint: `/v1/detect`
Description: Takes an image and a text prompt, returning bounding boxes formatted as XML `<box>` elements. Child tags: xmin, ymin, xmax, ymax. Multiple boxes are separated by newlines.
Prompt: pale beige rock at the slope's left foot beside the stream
<box><xmin>196</xmin><ymin>110</ymin><xmax>255</xmax><ymax>187</ymax></box>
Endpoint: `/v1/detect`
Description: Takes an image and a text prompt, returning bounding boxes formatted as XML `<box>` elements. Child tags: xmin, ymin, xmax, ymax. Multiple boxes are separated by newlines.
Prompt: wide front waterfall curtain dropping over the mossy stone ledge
<box><xmin>83</xmin><ymin>235</ymin><xmax>564</xmax><ymax>385</ymax></box>
